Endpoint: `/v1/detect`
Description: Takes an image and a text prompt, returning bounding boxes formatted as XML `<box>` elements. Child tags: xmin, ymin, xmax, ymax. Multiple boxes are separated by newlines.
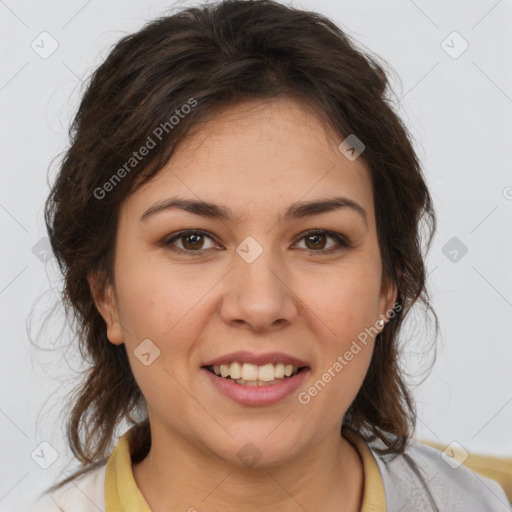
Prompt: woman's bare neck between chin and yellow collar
<box><xmin>133</xmin><ymin>428</ymin><xmax>364</xmax><ymax>512</ymax></box>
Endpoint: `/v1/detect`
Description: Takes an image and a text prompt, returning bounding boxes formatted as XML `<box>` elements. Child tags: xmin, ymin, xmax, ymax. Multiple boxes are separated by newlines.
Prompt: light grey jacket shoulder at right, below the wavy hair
<box><xmin>369</xmin><ymin>439</ymin><xmax>512</xmax><ymax>512</ymax></box>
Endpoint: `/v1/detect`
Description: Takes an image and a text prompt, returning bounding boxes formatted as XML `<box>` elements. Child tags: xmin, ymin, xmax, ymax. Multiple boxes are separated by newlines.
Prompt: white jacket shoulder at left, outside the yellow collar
<box><xmin>30</xmin><ymin>464</ymin><xmax>106</xmax><ymax>512</ymax></box>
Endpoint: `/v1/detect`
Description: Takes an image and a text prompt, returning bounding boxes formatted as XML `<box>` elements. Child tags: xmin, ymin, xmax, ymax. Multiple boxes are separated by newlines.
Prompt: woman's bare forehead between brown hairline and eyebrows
<box><xmin>122</xmin><ymin>99</ymin><xmax>373</xmax><ymax>224</ymax></box>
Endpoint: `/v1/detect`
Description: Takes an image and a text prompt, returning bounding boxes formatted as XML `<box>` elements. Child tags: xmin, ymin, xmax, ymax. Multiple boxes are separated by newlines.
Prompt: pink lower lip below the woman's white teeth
<box><xmin>201</xmin><ymin>368</ymin><xmax>309</xmax><ymax>406</ymax></box>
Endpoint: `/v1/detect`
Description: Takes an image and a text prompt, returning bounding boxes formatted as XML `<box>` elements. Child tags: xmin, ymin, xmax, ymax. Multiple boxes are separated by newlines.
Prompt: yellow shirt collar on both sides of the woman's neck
<box><xmin>105</xmin><ymin>431</ymin><xmax>386</xmax><ymax>512</ymax></box>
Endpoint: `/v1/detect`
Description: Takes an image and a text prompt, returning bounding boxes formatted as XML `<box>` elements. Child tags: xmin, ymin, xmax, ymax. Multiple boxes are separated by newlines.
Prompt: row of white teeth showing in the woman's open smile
<box><xmin>204</xmin><ymin>361</ymin><xmax>308</xmax><ymax>386</ymax></box>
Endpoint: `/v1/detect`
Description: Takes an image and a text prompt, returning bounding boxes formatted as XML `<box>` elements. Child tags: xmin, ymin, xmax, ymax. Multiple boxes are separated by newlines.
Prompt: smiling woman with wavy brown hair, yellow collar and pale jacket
<box><xmin>31</xmin><ymin>0</ymin><xmax>508</xmax><ymax>512</ymax></box>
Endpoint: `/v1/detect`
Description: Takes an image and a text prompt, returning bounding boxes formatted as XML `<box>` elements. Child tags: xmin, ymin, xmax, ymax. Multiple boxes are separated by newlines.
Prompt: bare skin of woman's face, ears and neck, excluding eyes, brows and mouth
<box><xmin>90</xmin><ymin>98</ymin><xmax>396</xmax><ymax>512</ymax></box>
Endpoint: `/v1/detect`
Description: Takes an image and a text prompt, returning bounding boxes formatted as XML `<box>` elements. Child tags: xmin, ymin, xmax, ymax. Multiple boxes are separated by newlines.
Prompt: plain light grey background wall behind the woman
<box><xmin>0</xmin><ymin>0</ymin><xmax>512</xmax><ymax>511</ymax></box>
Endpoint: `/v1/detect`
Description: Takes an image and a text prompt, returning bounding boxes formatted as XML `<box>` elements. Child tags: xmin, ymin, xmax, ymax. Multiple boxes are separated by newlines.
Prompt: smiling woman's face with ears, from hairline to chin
<box><xmin>92</xmin><ymin>99</ymin><xmax>396</xmax><ymax>465</ymax></box>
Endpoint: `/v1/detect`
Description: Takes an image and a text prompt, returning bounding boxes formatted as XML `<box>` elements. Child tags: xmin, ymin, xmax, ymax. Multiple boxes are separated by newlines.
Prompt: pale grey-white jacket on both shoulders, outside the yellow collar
<box><xmin>30</xmin><ymin>440</ymin><xmax>512</xmax><ymax>512</ymax></box>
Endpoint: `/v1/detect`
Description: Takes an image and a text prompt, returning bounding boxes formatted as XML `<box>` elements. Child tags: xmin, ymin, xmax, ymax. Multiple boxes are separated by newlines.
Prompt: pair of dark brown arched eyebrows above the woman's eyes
<box><xmin>140</xmin><ymin>197</ymin><xmax>368</xmax><ymax>227</ymax></box>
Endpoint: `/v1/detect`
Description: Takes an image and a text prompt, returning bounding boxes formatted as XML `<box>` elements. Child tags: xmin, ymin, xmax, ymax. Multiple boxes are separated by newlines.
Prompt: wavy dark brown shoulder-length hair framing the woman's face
<box><xmin>45</xmin><ymin>0</ymin><xmax>437</xmax><ymax>496</ymax></box>
